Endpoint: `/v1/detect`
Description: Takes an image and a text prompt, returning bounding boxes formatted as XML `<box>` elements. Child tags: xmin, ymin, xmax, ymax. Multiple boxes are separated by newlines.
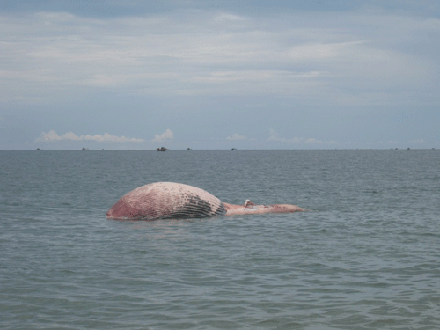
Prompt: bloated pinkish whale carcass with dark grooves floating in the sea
<box><xmin>106</xmin><ymin>182</ymin><xmax>303</xmax><ymax>220</ymax></box>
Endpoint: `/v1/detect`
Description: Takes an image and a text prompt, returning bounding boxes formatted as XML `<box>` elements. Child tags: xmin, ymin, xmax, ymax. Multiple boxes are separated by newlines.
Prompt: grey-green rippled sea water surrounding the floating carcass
<box><xmin>0</xmin><ymin>150</ymin><xmax>440</xmax><ymax>329</ymax></box>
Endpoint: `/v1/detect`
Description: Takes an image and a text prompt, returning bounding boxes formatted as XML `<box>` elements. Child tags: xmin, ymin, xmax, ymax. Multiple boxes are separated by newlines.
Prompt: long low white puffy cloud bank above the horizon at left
<box><xmin>34</xmin><ymin>130</ymin><xmax>145</xmax><ymax>143</ymax></box>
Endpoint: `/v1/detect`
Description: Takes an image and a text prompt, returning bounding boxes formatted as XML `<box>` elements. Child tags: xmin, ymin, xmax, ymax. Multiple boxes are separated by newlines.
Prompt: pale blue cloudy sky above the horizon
<box><xmin>0</xmin><ymin>0</ymin><xmax>440</xmax><ymax>150</ymax></box>
